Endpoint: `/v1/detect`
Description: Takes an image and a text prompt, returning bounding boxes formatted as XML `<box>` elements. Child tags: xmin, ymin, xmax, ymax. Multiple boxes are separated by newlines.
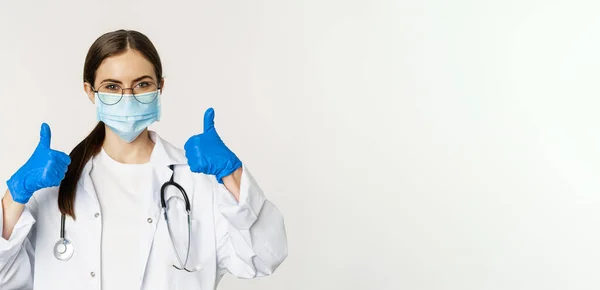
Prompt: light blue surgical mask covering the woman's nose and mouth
<box><xmin>95</xmin><ymin>92</ymin><xmax>160</xmax><ymax>143</ymax></box>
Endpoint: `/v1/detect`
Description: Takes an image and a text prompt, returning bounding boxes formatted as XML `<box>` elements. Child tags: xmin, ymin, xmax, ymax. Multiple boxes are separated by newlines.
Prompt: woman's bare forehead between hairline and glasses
<box><xmin>96</xmin><ymin>50</ymin><xmax>156</xmax><ymax>83</ymax></box>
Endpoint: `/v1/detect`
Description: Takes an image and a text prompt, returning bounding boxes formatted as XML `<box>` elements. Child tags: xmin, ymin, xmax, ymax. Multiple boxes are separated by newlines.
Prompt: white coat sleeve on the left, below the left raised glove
<box><xmin>0</xmin><ymin>191</ymin><xmax>38</xmax><ymax>290</ymax></box>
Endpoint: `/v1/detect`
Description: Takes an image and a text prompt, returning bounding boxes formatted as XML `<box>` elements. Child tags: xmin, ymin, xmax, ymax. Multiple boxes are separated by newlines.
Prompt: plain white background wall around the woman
<box><xmin>0</xmin><ymin>0</ymin><xmax>600</xmax><ymax>290</ymax></box>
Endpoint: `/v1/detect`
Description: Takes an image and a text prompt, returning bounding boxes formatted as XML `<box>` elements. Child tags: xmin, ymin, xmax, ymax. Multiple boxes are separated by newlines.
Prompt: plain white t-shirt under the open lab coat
<box><xmin>90</xmin><ymin>149</ymin><xmax>153</xmax><ymax>290</ymax></box>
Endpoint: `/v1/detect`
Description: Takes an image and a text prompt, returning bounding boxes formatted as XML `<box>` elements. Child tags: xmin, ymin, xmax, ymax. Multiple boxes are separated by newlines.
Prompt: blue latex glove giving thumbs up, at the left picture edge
<box><xmin>6</xmin><ymin>123</ymin><xmax>71</xmax><ymax>204</ymax></box>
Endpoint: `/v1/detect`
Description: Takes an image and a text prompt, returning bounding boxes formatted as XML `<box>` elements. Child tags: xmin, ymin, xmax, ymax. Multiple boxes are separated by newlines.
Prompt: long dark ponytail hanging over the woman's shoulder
<box><xmin>58</xmin><ymin>122</ymin><xmax>106</xmax><ymax>219</ymax></box>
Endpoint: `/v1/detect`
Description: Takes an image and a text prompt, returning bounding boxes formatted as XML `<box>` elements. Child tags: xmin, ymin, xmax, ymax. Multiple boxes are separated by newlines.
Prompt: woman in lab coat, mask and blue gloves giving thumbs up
<box><xmin>0</xmin><ymin>30</ymin><xmax>287</xmax><ymax>290</ymax></box>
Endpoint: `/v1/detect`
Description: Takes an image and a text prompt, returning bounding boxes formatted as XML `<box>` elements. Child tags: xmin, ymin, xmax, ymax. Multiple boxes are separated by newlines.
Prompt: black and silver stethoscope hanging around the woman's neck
<box><xmin>54</xmin><ymin>165</ymin><xmax>197</xmax><ymax>272</ymax></box>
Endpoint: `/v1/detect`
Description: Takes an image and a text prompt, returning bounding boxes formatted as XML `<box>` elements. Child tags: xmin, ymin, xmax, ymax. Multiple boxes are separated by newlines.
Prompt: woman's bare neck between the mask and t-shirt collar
<box><xmin>102</xmin><ymin>126</ymin><xmax>154</xmax><ymax>164</ymax></box>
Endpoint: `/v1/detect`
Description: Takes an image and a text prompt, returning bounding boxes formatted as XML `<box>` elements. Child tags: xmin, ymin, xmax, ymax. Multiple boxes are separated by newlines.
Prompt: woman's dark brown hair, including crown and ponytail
<box><xmin>58</xmin><ymin>29</ymin><xmax>162</xmax><ymax>219</ymax></box>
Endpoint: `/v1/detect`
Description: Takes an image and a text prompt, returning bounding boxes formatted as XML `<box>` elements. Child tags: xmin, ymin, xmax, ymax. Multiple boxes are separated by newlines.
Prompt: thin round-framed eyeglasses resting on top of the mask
<box><xmin>92</xmin><ymin>81</ymin><xmax>160</xmax><ymax>105</ymax></box>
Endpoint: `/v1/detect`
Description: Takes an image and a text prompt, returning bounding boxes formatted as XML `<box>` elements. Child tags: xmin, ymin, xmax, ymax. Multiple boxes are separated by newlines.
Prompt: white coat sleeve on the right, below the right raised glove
<box><xmin>214</xmin><ymin>167</ymin><xmax>287</xmax><ymax>279</ymax></box>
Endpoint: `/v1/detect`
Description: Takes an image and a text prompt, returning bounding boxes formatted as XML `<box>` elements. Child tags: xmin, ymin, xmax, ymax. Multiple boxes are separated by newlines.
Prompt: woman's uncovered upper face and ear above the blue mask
<box><xmin>84</xmin><ymin>50</ymin><xmax>164</xmax><ymax>103</ymax></box>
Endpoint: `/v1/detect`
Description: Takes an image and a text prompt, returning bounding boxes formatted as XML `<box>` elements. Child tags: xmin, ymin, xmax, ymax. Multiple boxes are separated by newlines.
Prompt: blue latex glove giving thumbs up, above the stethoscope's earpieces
<box><xmin>183</xmin><ymin>108</ymin><xmax>242</xmax><ymax>183</ymax></box>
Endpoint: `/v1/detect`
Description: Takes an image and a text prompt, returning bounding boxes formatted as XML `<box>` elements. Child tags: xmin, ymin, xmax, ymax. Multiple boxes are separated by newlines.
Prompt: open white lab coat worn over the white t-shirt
<box><xmin>0</xmin><ymin>132</ymin><xmax>287</xmax><ymax>290</ymax></box>
